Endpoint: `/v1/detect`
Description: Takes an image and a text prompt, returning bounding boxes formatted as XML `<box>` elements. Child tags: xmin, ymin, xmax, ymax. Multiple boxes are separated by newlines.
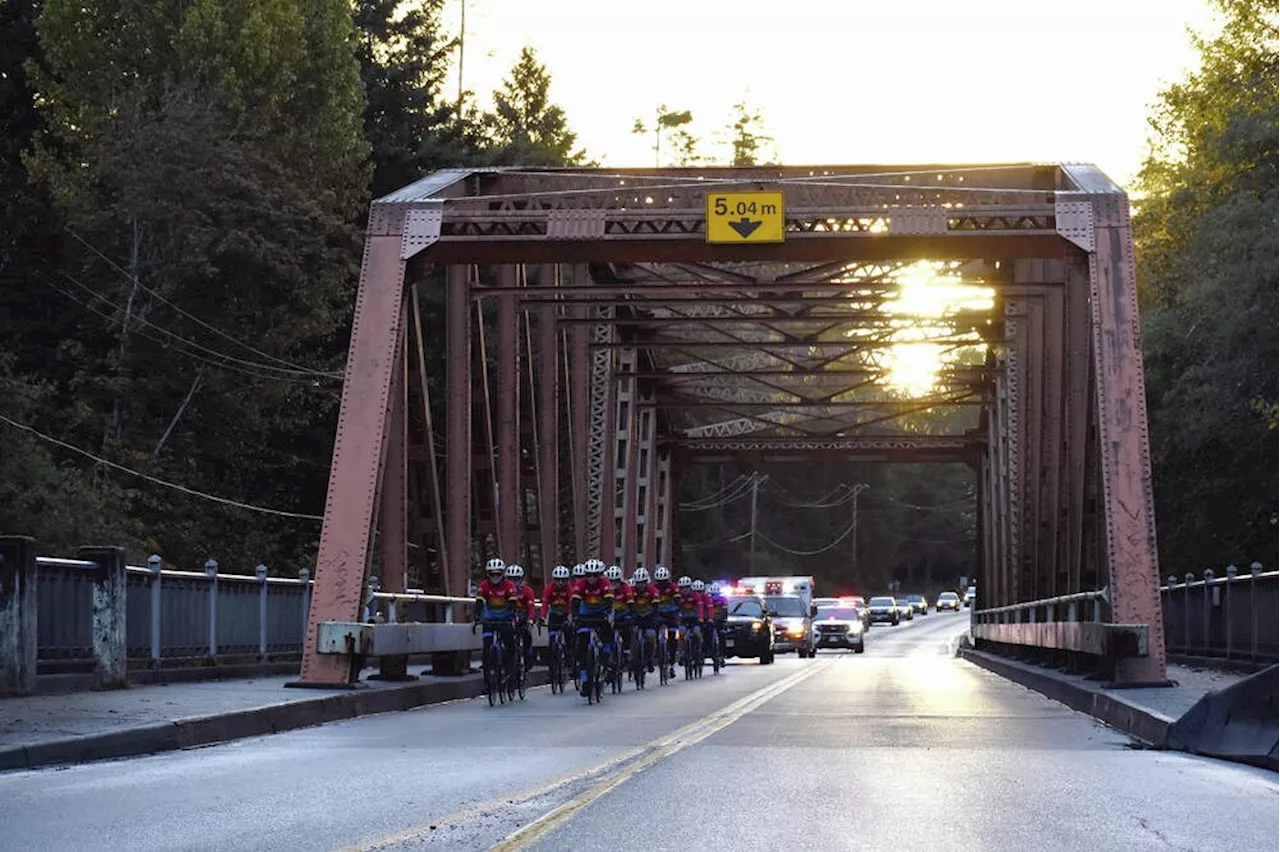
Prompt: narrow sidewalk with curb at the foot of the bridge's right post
<box><xmin>961</xmin><ymin>649</ymin><xmax>1248</xmax><ymax>747</ymax></box>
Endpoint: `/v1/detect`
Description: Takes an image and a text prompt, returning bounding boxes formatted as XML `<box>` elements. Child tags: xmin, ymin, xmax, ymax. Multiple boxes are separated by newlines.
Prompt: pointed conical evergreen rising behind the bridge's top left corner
<box><xmin>485</xmin><ymin>47</ymin><xmax>586</xmax><ymax>166</ymax></box>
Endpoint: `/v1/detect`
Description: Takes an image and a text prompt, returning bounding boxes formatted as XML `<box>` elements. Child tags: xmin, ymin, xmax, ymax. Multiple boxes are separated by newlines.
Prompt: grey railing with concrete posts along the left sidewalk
<box><xmin>0</xmin><ymin>536</ymin><xmax>483</xmax><ymax>693</ymax></box>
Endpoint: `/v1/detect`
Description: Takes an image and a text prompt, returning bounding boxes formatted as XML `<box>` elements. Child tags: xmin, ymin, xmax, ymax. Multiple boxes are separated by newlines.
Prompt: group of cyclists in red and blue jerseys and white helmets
<box><xmin>472</xmin><ymin>559</ymin><xmax>728</xmax><ymax>702</ymax></box>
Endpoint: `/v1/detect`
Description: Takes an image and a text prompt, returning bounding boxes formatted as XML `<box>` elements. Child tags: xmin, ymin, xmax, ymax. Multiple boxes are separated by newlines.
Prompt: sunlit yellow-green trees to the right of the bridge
<box><xmin>1135</xmin><ymin>0</ymin><xmax>1280</xmax><ymax>573</ymax></box>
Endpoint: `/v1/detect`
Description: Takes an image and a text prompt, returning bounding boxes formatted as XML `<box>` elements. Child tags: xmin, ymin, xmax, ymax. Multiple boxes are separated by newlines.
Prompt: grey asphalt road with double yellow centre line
<box><xmin>0</xmin><ymin>614</ymin><xmax>1280</xmax><ymax>852</ymax></box>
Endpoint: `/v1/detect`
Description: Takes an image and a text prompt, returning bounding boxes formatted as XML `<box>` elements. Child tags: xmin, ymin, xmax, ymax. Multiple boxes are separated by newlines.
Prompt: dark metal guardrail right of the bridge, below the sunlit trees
<box><xmin>1160</xmin><ymin>562</ymin><xmax>1280</xmax><ymax>663</ymax></box>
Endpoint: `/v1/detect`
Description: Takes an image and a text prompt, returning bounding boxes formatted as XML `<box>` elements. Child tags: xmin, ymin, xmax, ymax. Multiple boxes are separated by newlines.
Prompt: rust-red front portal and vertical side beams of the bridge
<box><xmin>301</xmin><ymin>164</ymin><xmax>1165</xmax><ymax>686</ymax></box>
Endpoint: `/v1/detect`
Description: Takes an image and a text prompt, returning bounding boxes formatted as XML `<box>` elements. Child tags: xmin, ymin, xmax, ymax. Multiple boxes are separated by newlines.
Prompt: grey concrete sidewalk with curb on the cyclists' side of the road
<box><xmin>0</xmin><ymin>669</ymin><xmax>527</xmax><ymax>771</ymax></box>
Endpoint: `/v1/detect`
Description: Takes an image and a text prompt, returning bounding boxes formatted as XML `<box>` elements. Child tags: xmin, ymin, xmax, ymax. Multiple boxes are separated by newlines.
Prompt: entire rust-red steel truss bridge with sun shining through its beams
<box><xmin>294</xmin><ymin>164</ymin><xmax>1165</xmax><ymax>686</ymax></box>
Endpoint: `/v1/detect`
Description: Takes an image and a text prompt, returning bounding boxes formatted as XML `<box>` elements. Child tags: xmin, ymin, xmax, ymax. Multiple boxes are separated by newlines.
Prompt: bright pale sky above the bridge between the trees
<box><xmin>445</xmin><ymin>0</ymin><xmax>1213</xmax><ymax>183</ymax></box>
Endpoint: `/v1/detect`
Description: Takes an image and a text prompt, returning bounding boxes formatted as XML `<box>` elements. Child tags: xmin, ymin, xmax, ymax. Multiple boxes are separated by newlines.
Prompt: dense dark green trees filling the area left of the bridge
<box><xmin>0</xmin><ymin>0</ymin><xmax>581</xmax><ymax>573</ymax></box>
